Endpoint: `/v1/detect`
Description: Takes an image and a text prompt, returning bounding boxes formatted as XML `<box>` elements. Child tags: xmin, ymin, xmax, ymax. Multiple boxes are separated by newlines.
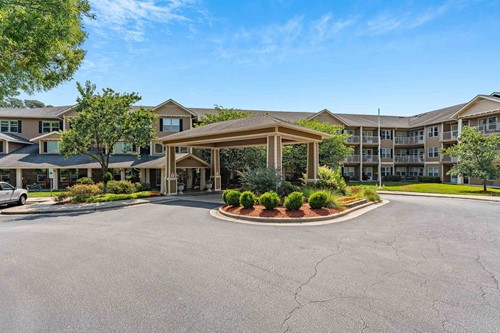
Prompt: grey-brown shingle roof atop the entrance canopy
<box><xmin>160</xmin><ymin>114</ymin><xmax>330</xmax><ymax>141</ymax></box>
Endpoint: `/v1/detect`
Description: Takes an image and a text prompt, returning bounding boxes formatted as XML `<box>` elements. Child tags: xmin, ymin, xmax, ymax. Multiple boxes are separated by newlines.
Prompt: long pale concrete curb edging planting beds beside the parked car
<box><xmin>1</xmin><ymin>197</ymin><xmax>178</xmax><ymax>215</ymax></box>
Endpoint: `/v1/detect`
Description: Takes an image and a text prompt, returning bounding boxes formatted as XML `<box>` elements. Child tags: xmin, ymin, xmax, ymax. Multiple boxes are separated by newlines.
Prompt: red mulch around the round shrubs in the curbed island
<box><xmin>222</xmin><ymin>204</ymin><xmax>340</xmax><ymax>218</ymax></box>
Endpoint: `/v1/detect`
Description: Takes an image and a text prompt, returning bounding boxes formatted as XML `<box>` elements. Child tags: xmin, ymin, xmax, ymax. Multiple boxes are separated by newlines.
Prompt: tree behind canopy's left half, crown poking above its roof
<box><xmin>198</xmin><ymin>105</ymin><xmax>266</xmax><ymax>180</ymax></box>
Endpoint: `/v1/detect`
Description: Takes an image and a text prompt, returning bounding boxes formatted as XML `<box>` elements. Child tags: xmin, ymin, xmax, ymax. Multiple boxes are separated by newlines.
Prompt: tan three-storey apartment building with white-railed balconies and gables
<box><xmin>0</xmin><ymin>93</ymin><xmax>500</xmax><ymax>190</ymax></box>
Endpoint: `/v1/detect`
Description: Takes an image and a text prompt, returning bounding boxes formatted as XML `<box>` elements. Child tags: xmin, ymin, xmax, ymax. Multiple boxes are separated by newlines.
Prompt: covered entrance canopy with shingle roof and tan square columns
<box><xmin>160</xmin><ymin>115</ymin><xmax>331</xmax><ymax>194</ymax></box>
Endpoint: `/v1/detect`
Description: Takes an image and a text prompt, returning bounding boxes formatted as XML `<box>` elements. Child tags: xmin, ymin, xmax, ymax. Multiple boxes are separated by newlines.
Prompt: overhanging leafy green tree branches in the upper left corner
<box><xmin>0</xmin><ymin>0</ymin><xmax>93</xmax><ymax>100</ymax></box>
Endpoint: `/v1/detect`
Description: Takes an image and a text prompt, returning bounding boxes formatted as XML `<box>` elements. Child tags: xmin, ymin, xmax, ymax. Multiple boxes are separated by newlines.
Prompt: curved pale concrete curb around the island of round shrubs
<box><xmin>210</xmin><ymin>200</ymin><xmax>390</xmax><ymax>227</ymax></box>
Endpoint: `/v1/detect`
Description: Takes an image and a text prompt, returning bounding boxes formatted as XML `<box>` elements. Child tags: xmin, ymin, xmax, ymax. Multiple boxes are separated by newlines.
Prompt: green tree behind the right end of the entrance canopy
<box><xmin>283</xmin><ymin>120</ymin><xmax>352</xmax><ymax>177</ymax></box>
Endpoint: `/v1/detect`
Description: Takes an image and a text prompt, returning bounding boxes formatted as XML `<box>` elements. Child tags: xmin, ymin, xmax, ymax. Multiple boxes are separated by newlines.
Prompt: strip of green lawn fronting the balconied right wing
<box><xmin>349</xmin><ymin>182</ymin><xmax>500</xmax><ymax>196</ymax></box>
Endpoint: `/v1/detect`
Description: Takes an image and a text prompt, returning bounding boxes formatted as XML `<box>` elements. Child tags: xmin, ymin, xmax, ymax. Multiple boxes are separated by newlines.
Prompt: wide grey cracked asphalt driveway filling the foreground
<box><xmin>0</xmin><ymin>195</ymin><xmax>500</xmax><ymax>332</ymax></box>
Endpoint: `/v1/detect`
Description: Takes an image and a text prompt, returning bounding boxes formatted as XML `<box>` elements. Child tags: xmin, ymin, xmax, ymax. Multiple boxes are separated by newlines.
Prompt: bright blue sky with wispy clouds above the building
<box><xmin>22</xmin><ymin>0</ymin><xmax>500</xmax><ymax>115</ymax></box>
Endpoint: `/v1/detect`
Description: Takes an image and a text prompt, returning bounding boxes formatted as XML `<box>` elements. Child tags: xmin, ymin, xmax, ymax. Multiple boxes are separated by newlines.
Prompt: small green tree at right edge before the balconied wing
<box><xmin>441</xmin><ymin>126</ymin><xmax>500</xmax><ymax>192</ymax></box>
